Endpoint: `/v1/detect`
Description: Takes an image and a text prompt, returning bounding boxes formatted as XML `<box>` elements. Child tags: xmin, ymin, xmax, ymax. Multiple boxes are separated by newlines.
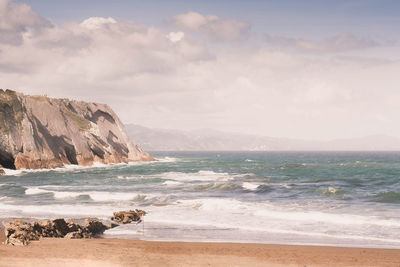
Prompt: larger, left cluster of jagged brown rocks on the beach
<box><xmin>3</xmin><ymin>219</ymin><xmax>109</xmax><ymax>245</ymax></box>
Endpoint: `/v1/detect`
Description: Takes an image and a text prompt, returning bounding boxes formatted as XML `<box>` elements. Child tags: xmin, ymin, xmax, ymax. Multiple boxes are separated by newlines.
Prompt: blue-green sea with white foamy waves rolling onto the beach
<box><xmin>0</xmin><ymin>152</ymin><xmax>400</xmax><ymax>248</ymax></box>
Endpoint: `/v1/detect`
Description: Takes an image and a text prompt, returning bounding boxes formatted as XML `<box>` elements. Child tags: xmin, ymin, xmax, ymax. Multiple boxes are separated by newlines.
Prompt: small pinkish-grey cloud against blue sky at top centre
<box><xmin>173</xmin><ymin>12</ymin><xmax>250</xmax><ymax>41</ymax></box>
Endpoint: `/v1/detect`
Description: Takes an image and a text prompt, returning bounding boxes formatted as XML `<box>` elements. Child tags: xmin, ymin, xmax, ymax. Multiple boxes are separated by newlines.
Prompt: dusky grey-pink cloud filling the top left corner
<box><xmin>0</xmin><ymin>0</ymin><xmax>52</xmax><ymax>45</ymax></box>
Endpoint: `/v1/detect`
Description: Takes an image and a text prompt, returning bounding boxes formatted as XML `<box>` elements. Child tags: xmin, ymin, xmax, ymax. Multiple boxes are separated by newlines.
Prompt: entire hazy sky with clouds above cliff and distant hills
<box><xmin>0</xmin><ymin>0</ymin><xmax>400</xmax><ymax>139</ymax></box>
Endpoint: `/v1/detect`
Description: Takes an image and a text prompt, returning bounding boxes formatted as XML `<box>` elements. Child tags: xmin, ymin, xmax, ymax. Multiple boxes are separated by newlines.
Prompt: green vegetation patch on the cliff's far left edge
<box><xmin>0</xmin><ymin>89</ymin><xmax>24</xmax><ymax>134</ymax></box>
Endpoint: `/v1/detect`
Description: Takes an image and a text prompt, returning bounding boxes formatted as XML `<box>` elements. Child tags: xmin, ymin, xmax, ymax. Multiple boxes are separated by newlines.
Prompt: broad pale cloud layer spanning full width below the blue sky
<box><xmin>0</xmin><ymin>0</ymin><xmax>400</xmax><ymax>138</ymax></box>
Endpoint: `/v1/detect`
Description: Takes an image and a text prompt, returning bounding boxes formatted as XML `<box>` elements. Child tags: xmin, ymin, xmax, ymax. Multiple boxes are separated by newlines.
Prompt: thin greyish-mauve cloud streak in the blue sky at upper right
<box><xmin>265</xmin><ymin>34</ymin><xmax>379</xmax><ymax>53</ymax></box>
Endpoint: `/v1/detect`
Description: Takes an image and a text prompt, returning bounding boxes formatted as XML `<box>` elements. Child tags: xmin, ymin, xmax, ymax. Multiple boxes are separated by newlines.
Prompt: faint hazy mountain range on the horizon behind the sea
<box><xmin>125</xmin><ymin>124</ymin><xmax>400</xmax><ymax>151</ymax></box>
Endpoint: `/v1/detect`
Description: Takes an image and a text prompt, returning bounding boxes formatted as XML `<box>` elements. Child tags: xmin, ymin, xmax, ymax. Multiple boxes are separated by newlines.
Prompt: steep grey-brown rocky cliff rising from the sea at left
<box><xmin>0</xmin><ymin>90</ymin><xmax>153</xmax><ymax>169</ymax></box>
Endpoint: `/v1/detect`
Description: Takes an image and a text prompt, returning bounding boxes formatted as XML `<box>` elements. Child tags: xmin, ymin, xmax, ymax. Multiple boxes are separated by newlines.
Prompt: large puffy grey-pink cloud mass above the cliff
<box><xmin>0</xmin><ymin>9</ymin><xmax>213</xmax><ymax>88</ymax></box>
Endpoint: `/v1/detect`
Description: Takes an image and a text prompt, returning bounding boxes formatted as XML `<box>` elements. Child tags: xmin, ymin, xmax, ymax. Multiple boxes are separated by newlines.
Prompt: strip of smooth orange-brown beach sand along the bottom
<box><xmin>0</xmin><ymin>230</ymin><xmax>400</xmax><ymax>267</ymax></box>
